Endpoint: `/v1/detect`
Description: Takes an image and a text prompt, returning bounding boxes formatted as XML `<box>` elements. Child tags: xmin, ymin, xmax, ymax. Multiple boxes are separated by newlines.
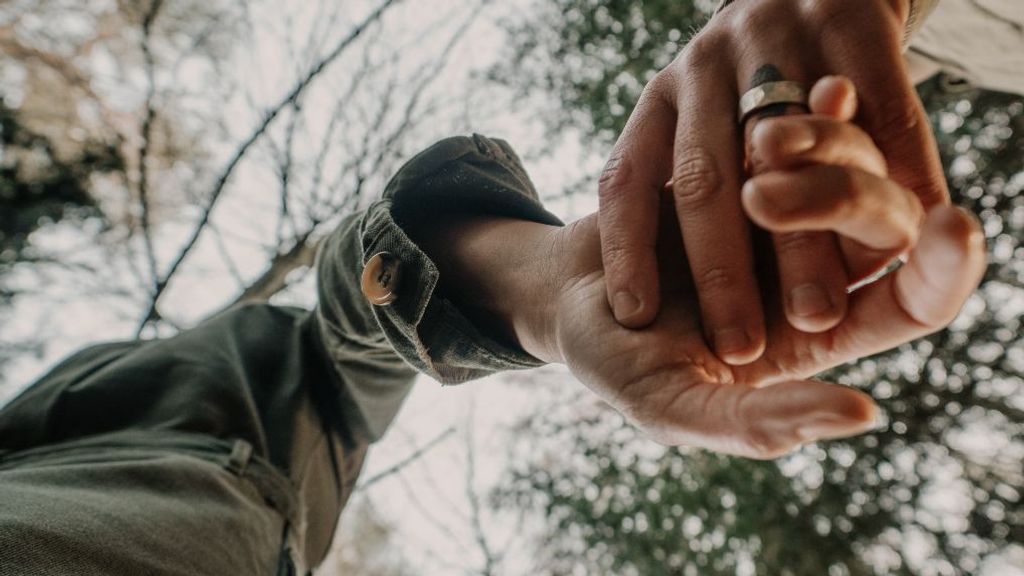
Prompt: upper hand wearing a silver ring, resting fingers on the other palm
<box><xmin>599</xmin><ymin>0</ymin><xmax>949</xmax><ymax>365</ymax></box>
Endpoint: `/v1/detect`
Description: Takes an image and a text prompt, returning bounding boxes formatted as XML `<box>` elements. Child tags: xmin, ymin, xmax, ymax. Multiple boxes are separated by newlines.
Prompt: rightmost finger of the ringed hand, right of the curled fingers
<box><xmin>820</xmin><ymin>2</ymin><xmax>949</xmax><ymax>208</ymax></box>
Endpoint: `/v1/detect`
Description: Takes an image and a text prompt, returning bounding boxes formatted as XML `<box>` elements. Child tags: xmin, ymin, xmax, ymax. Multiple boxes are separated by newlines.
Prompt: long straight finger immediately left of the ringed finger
<box><xmin>673</xmin><ymin>44</ymin><xmax>765</xmax><ymax>364</ymax></box>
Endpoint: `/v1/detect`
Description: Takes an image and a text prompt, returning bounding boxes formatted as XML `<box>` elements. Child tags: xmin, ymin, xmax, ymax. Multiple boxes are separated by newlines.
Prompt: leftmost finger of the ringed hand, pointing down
<box><xmin>598</xmin><ymin>80</ymin><xmax>676</xmax><ymax>328</ymax></box>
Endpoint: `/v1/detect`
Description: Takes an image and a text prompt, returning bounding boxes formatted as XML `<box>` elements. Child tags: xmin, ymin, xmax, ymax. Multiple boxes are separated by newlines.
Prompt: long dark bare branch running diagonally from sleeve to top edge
<box><xmin>136</xmin><ymin>0</ymin><xmax>400</xmax><ymax>336</ymax></box>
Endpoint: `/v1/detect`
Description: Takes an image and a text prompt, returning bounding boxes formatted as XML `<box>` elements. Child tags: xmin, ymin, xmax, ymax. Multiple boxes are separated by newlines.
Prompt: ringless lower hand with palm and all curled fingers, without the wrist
<box><xmin>537</xmin><ymin>78</ymin><xmax>985</xmax><ymax>458</ymax></box>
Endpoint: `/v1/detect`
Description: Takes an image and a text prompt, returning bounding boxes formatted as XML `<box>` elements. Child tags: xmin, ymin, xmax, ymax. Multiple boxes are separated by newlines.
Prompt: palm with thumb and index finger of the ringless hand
<box><xmin>558</xmin><ymin>203</ymin><xmax>984</xmax><ymax>457</ymax></box>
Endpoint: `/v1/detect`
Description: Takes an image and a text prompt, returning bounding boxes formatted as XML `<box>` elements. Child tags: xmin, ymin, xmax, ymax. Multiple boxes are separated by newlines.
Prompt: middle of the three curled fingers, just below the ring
<box><xmin>751</xmin><ymin>115</ymin><xmax>888</xmax><ymax>176</ymax></box>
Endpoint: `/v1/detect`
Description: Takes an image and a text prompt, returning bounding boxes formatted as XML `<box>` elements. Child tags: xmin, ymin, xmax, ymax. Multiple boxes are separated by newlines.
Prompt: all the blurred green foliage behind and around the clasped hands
<box><xmin>494</xmin><ymin>0</ymin><xmax>1024</xmax><ymax>576</ymax></box>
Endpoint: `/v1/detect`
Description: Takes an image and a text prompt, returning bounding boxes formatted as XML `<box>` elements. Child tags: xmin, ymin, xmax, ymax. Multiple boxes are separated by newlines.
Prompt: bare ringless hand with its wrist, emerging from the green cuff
<box><xmin>411</xmin><ymin>80</ymin><xmax>984</xmax><ymax>458</ymax></box>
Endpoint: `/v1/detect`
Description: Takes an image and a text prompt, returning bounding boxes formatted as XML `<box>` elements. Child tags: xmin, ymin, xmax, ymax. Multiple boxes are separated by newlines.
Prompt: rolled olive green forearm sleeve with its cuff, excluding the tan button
<box><xmin>316</xmin><ymin>134</ymin><xmax>561</xmax><ymax>440</ymax></box>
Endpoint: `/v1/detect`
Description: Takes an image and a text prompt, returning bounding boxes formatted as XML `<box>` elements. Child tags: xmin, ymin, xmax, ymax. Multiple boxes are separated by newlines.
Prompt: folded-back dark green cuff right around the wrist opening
<box><xmin>360</xmin><ymin>135</ymin><xmax>561</xmax><ymax>383</ymax></box>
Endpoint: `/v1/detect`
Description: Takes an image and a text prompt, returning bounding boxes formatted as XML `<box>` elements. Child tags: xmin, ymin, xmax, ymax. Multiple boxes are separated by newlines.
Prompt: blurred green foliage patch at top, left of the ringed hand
<box><xmin>490</xmin><ymin>0</ymin><xmax>714</xmax><ymax>139</ymax></box>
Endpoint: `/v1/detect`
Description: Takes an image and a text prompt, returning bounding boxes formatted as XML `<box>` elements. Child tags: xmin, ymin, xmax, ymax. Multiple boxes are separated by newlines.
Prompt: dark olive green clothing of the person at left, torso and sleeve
<box><xmin>0</xmin><ymin>135</ymin><xmax>560</xmax><ymax>576</ymax></box>
